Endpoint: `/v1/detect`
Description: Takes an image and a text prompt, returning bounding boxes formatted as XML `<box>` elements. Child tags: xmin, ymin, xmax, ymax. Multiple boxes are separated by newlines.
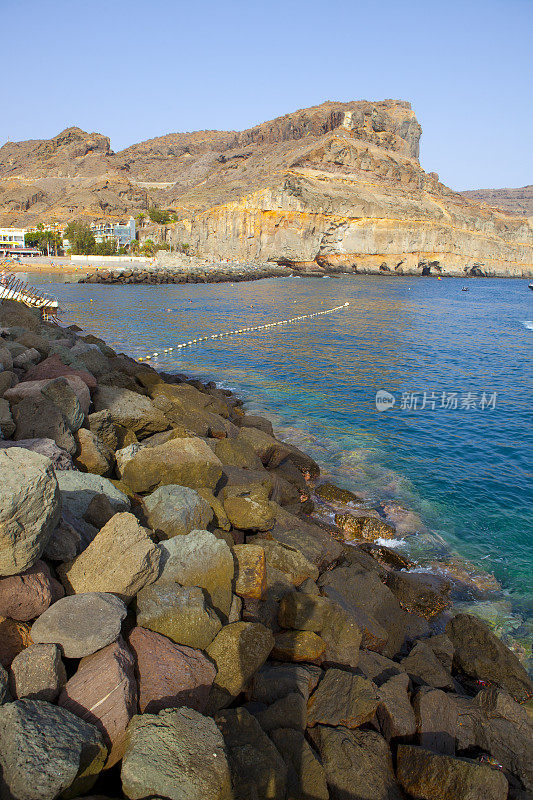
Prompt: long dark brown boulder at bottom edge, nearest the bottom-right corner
<box><xmin>397</xmin><ymin>744</ymin><xmax>508</xmax><ymax>800</ymax></box>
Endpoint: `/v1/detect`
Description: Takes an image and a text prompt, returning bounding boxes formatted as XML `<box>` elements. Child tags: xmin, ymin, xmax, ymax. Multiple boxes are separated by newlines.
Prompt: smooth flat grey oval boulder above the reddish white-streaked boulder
<box><xmin>31</xmin><ymin>592</ymin><xmax>126</xmax><ymax>658</ymax></box>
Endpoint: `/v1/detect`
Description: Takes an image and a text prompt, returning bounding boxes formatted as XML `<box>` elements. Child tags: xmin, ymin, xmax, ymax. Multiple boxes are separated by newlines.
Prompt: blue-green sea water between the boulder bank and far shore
<box><xmin>29</xmin><ymin>276</ymin><xmax>533</xmax><ymax>658</ymax></box>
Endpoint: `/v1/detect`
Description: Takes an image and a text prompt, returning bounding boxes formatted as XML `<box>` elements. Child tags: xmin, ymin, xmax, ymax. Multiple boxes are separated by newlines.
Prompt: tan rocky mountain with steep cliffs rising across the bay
<box><xmin>0</xmin><ymin>100</ymin><xmax>533</xmax><ymax>275</ymax></box>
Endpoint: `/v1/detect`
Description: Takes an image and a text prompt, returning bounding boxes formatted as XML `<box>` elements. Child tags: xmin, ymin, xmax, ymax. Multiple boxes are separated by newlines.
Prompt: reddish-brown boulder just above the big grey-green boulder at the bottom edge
<box><xmin>128</xmin><ymin>627</ymin><xmax>216</xmax><ymax>714</ymax></box>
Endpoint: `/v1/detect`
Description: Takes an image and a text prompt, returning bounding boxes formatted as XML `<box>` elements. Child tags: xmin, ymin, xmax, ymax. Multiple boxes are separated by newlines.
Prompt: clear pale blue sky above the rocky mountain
<box><xmin>0</xmin><ymin>0</ymin><xmax>533</xmax><ymax>189</ymax></box>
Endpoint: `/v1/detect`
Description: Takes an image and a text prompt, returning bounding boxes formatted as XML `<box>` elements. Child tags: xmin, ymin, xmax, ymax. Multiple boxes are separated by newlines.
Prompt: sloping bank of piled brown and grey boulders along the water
<box><xmin>0</xmin><ymin>301</ymin><xmax>533</xmax><ymax>800</ymax></box>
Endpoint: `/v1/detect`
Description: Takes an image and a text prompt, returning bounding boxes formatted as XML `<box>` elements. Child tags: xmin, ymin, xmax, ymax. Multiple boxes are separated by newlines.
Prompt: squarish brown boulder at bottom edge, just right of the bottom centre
<box><xmin>312</xmin><ymin>725</ymin><xmax>402</xmax><ymax>800</ymax></box>
